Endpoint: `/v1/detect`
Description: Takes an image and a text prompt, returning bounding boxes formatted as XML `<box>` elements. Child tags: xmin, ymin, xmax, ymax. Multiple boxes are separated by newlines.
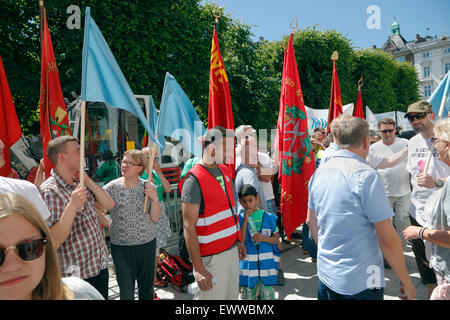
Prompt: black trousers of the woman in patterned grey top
<box><xmin>111</xmin><ymin>239</ymin><xmax>156</xmax><ymax>300</ymax></box>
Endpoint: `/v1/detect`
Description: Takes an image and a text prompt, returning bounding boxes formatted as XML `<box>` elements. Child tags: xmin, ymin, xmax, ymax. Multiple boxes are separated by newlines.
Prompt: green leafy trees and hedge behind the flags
<box><xmin>0</xmin><ymin>0</ymin><xmax>419</xmax><ymax>134</ymax></box>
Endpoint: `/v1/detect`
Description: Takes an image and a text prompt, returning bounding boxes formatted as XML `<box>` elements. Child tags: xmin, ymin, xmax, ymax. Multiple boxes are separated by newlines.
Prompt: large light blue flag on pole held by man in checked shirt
<box><xmin>81</xmin><ymin>7</ymin><xmax>160</xmax><ymax>144</ymax></box>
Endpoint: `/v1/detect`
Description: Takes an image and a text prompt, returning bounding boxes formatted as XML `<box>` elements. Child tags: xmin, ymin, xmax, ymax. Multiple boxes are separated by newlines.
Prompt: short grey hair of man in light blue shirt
<box><xmin>335</xmin><ymin>114</ymin><xmax>369</xmax><ymax>149</ymax></box>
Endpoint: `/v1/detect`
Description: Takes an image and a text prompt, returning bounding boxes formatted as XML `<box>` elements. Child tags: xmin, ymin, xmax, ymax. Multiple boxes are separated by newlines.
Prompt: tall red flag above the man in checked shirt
<box><xmin>39</xmin><ymin>6</ymin><xmax>70</xmax><ymax>178</ymax></box>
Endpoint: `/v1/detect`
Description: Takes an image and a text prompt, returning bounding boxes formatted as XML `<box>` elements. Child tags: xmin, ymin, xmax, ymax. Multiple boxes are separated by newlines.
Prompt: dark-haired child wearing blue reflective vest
<box><xmin>238</xmin><ymin>184</ymin><xmax>281</xmax><ymax>300</ymax></box>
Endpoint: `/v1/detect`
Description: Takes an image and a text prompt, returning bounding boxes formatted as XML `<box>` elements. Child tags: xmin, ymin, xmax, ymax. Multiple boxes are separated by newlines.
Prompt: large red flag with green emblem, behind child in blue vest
<box><xmin>278</xmin><ymin>34</ymin><xmax>315</xmax><ymax>238</ymax></box>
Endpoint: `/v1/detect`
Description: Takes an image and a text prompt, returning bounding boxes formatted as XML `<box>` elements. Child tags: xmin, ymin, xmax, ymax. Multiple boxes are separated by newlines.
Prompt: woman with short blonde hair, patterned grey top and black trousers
<box><xmin>103</xmin><ymin>149</ymin><xmax>161</xmax><ymax>300</ymax></box>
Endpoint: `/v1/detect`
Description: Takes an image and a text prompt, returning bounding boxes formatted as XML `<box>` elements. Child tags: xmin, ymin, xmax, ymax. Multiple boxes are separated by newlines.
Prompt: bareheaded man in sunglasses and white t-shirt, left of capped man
<box><xmin>369</xmin><ymin>118</ymin><xmax>411</xmax><ymax>250</ymax></box>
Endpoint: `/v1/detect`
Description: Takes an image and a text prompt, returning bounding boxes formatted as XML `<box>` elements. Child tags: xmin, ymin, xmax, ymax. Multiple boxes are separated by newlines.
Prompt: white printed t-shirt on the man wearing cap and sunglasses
<box><xmin>406</xmin><ymin>134</ymin><xmax>450</xmax><ymax>226</ymax></box>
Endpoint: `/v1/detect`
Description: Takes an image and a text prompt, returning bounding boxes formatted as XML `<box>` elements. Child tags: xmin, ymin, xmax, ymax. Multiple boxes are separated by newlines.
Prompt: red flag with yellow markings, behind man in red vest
<box><xmin>208</xmin><ymin>27</ymin><xmax>235</xmax><ymax>178</ymax></box>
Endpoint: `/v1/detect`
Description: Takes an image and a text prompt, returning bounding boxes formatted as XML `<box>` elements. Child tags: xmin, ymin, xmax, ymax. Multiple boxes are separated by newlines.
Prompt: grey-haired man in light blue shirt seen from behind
<box><xmin>307</xmin><ymin>117</ymin><xmax>416</xmax><ymax>300</ymax></box>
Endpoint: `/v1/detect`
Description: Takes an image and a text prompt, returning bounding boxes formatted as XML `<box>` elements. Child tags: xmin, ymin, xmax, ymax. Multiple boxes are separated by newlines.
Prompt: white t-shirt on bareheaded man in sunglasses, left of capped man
<box><xmin>369</xmin><ymin>138</ymin><xmax>411</xmax><ymax>197</ymax></box>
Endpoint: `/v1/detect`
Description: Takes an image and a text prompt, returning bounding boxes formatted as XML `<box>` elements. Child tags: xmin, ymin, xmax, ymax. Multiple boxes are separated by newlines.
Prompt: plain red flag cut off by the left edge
<box><xmin>0</xmin><ymin>57</ymin><xmax>22</xmax><ymax>177</ymax></box>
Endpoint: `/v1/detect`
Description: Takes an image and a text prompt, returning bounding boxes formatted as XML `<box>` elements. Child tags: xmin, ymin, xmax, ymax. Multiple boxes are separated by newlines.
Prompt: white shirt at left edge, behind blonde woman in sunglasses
<box><xmin>0</xmin><ymin>177</ymin><xmax>50</xmax><ymax>221</ymax></box>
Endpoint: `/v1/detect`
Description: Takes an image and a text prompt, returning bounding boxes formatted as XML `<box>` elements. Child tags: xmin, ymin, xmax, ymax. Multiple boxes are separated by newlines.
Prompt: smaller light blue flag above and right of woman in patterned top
<box><xmin>156</xmin><ymin>72</ymin><xmax>206</xmax><ymax>157</ymax></box>
